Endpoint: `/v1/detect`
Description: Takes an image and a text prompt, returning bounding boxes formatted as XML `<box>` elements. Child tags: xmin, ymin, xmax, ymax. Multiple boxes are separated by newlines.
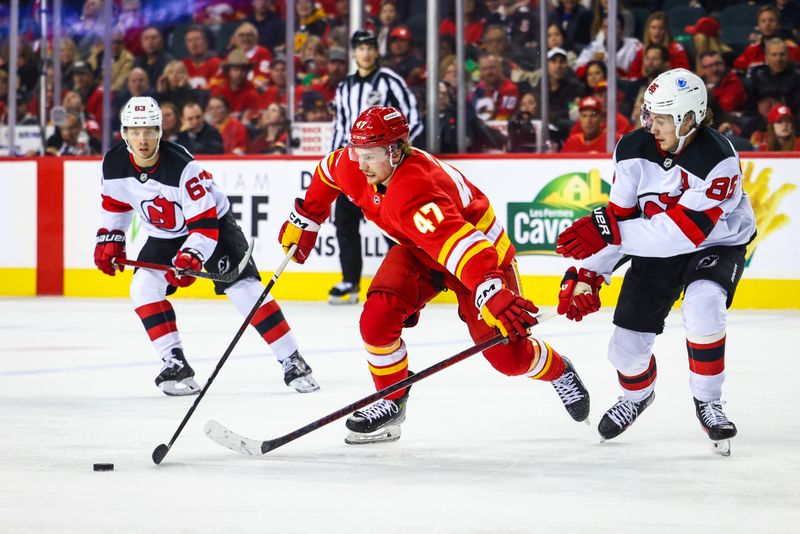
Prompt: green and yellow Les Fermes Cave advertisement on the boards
<box><xmin>506</xmin><ymin>169</ymin><xmax>611</xmax><ymax>254</ymax></box>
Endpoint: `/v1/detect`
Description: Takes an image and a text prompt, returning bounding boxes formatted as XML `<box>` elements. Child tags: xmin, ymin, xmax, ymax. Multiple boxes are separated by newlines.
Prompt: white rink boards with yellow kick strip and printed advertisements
<box><xmin>0</xmin><ymin>154</ymin><xmax>800</xmax><ymax>308</ymax></box>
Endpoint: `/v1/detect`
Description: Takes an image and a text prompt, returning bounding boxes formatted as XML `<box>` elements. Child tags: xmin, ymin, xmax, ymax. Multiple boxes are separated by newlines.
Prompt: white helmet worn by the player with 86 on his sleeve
<box><xmin>640</xmin><ymin>69</ymin><xmax>708</xmax><ymax>152</ymax></box>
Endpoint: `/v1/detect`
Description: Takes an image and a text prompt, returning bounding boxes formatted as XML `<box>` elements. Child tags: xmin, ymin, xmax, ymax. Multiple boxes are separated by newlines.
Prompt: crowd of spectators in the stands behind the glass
<box><xmin>0</xmin><ymin>0</ymin><xmax>800</xmax><ymax>154</ymax></box>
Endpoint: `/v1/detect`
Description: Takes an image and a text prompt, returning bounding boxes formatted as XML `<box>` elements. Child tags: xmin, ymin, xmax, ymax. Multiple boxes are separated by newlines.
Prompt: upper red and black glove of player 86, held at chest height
<box><xmin>556</xmin><ymin>207</ymin><xmax>621</xmax><ymax>260</ymax></box>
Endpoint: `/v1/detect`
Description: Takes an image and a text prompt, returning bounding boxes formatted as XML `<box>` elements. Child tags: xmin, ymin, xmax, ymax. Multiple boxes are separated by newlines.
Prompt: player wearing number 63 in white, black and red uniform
<box><xmin>94</xmin><ymin>97</ymin><xmax>319</xmax><ymax>395</ymax></box>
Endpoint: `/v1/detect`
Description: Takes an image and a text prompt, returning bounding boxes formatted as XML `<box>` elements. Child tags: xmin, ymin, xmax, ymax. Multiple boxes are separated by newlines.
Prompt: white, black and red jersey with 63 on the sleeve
<box><xmin>101</xmin><ymin>141</ymin><xmax>230</xmax><ymax>260</ymax></box>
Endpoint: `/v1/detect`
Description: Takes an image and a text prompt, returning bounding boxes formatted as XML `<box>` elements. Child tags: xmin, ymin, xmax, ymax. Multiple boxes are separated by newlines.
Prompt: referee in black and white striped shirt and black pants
<box><xmin>330</xmin><ymin>30</ymin><xmax>422</xmax><ymax>304</ymax></box>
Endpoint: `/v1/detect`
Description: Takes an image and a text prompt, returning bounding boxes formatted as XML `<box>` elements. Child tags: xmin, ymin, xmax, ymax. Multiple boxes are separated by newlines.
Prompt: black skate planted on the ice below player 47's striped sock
<box><xmin>344</xmin><ymin>388</ymin><xmax>410</xmax><ymax>445</ymax></box>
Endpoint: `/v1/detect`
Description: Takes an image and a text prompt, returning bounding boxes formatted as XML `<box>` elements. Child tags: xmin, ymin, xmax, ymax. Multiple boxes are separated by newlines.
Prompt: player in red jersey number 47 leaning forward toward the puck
<box><xmin>279</xmin><ymin>106</ymin><xmax>589</xmax><ymax>444</ymax></box>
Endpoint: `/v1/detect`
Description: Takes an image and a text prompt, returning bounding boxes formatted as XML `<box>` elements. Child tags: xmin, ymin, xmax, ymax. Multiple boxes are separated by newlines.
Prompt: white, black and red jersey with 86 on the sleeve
<box><xmin>584</xmin><ymin>127</ymin><xmax>756</xmax><ymax>274</ymax></box>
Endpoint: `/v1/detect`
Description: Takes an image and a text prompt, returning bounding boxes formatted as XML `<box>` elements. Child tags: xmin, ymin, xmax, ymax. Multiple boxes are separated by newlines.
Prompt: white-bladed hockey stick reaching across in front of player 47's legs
<box><xmin>203</xmin><ymin>309</ymin><xmax>557</xmax><ymax>456</ymax></box>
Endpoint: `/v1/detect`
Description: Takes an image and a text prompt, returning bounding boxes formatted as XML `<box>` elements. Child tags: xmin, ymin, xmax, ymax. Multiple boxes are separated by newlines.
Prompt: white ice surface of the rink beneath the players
<box><xmin>0</xmin><ymin>298</ymin><xmax>800</xmax><ymax>534</ymax></box>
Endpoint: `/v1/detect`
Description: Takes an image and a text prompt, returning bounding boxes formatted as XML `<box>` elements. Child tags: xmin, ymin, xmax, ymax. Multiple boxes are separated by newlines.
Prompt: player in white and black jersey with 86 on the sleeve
<box><xmin>556</xmin><ymin>69</ymin><xmax>756</xmax><ymax>455</ymax></box>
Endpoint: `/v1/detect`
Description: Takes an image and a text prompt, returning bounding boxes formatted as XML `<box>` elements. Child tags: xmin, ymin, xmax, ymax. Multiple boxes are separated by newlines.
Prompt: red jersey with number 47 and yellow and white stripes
<box><xmin>303</xmin><ymin>149</ymin><xmax>515</xmax><ymax>291</ymax></box>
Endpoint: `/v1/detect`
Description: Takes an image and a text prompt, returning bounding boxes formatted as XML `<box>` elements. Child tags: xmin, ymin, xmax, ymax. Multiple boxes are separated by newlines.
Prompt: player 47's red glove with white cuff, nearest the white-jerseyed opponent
<box><xmin>475</xmin><ymin>278</ymin><xmax>539</xmax><ymax>341</ymax></box>
